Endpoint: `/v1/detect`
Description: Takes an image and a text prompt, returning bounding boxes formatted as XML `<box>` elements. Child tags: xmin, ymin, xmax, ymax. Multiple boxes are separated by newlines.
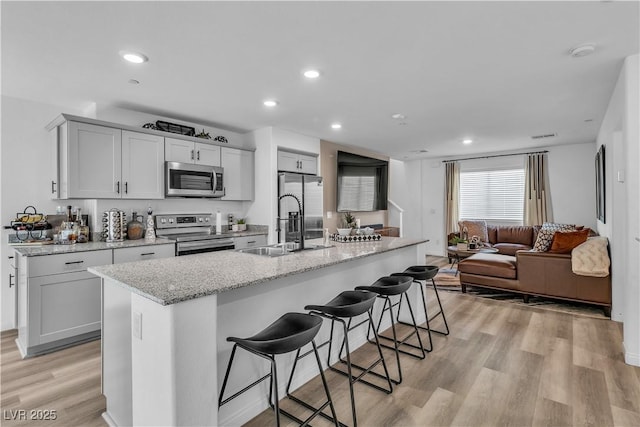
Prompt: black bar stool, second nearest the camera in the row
<box><xmin>302</xmin><ymin>290</ymin><xmax>393</xmax><ymax>427</ymax></box>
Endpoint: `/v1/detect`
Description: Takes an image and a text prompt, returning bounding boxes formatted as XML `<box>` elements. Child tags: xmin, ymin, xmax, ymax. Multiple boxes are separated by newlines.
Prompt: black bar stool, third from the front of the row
<box><xmin>356</xmin><ymin>276</ymin><xmax>426</xmax><ymax>384</ymax></box>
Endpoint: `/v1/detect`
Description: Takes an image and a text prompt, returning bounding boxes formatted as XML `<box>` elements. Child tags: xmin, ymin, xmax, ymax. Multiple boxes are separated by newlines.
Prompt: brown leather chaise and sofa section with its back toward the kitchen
<box><xmin>458</xmin><ymin>246</ymin><xmax>611</xmax><ymax>316</ymax></box>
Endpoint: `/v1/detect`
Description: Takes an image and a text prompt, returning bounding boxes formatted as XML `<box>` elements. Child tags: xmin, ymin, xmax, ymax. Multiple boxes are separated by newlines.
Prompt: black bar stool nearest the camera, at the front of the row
<box><xmin>218</xmin><ymin>313</ymin><xmax>338</xmax><ymax>426</ymax></box>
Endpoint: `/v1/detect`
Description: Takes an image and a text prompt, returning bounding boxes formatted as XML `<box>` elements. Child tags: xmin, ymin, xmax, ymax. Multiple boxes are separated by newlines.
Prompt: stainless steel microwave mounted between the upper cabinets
<box><xmin>165</xmin><ymin>162</ymin><xmax>224</xmax><ymax>197</ymax></box>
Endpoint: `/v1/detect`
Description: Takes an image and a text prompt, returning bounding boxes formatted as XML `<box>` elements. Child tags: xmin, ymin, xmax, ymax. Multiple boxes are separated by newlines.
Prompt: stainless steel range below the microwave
<box><xmin>155</xmin><ymin>214</ymin><xmax>235</xmax><ymax>256</ymax></box>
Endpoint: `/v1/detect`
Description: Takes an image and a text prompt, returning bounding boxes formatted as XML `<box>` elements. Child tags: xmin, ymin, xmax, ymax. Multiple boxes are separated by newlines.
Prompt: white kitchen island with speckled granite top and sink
<box><xmin>89</xmin><ymin>237</ymin><xmax>425</xmax><ymax>426</ymax></box>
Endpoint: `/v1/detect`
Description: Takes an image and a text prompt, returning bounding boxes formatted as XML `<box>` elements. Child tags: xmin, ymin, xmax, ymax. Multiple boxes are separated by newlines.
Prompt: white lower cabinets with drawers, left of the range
<box><xmin>15</xmin><ymin>243</ymin><xmax>175</xmax><ymax>357</ymax></box>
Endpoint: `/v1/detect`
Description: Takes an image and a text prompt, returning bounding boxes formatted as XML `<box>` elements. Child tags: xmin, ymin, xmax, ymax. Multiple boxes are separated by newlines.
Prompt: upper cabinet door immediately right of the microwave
<box><xmin>221</xmin><ymin>147</ymin><xmax>254</xmax><ymax>200</ymax></box>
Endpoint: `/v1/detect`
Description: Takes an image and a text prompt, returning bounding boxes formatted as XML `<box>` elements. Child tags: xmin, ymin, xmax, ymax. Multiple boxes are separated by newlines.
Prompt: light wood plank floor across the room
<box><xmin>0</xmin><ymin>291</ymin><xmax>640</xmax><ymax>427</ymax></box>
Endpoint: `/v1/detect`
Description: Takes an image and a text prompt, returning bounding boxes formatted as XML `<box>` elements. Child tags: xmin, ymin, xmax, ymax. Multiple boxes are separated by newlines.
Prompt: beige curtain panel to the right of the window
<box><xmin>523</xmin><ymin>153</ymin><xmax>553</xmax><ymax>225</ymax></box>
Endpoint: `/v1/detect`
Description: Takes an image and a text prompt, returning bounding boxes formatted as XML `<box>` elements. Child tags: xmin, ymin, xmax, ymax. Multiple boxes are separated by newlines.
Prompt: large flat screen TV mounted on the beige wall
<box><xmin>336</xmin><ymin>151</ymin><xmax>389</xmax><ymax>212</ymax></box>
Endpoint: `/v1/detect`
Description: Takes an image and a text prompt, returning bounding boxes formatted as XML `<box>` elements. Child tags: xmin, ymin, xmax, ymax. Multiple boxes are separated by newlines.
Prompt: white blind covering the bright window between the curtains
<box><xmin>460</xmin><ymin>168</ymin><xmax>524</xmax><ymax>224</ymax></box>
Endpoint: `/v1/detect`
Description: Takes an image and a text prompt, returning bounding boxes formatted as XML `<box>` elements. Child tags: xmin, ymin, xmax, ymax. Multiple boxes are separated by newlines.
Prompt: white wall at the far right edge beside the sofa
<box><xmin>597</xmin><ymin>55</ymin><xmax>640</xmax><ymax>366</ymax></box>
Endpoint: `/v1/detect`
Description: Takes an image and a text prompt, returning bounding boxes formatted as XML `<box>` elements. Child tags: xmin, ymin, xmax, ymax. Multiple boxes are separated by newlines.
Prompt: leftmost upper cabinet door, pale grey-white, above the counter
<box><xmin>67</xmin><ymin>122</ymin><xmax>122</xmax><ymax>199</ymax></box>
